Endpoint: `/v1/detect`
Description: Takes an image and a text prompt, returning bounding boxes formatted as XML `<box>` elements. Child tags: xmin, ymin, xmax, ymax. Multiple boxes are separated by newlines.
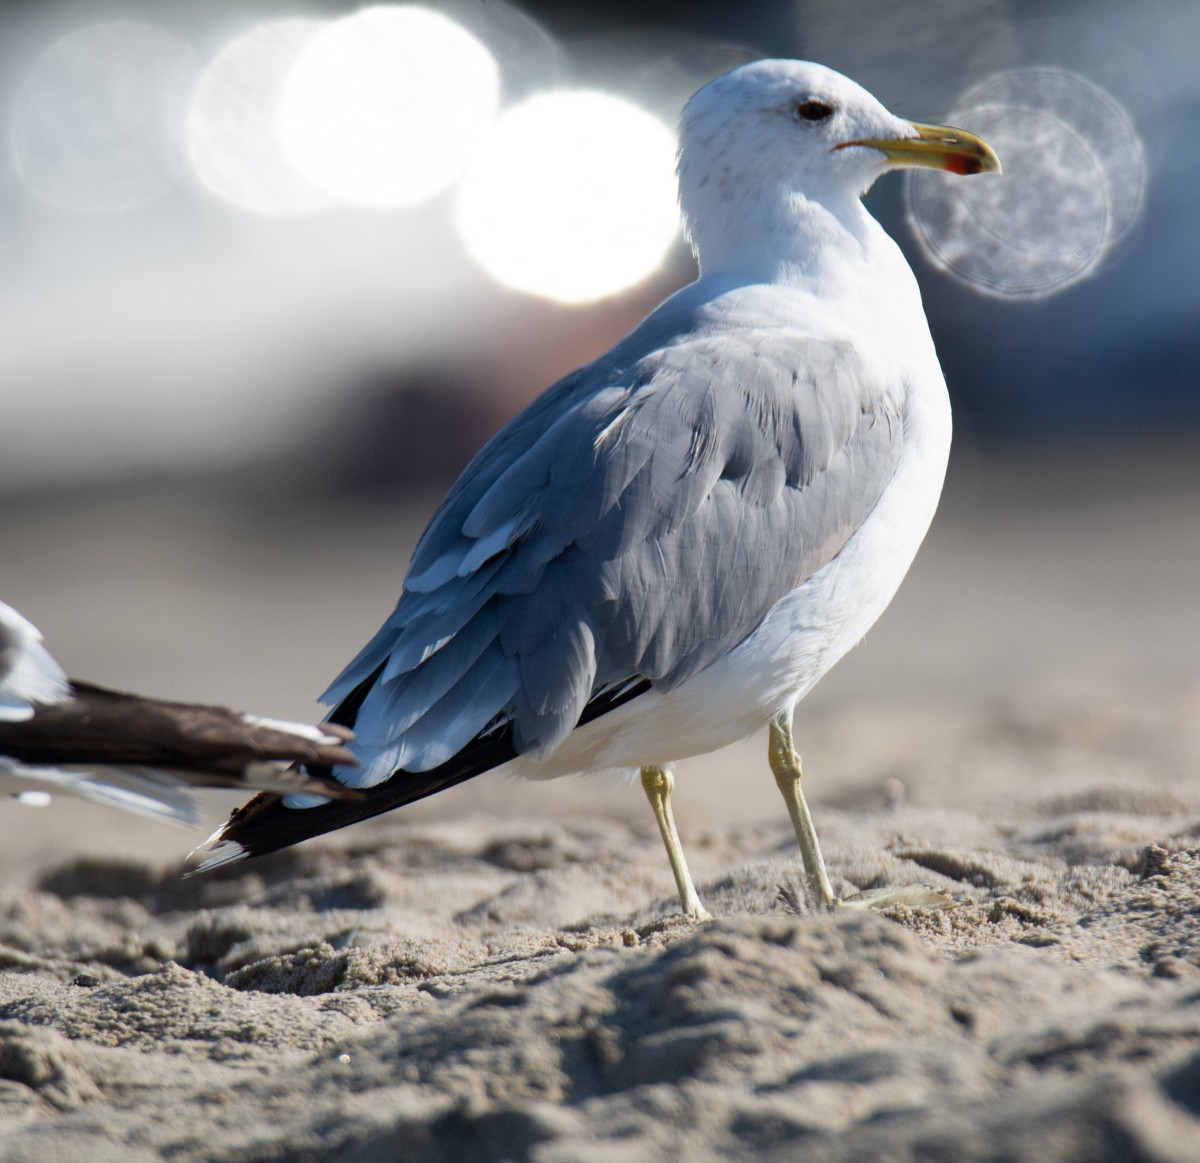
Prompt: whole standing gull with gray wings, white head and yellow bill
<box><xmin>193</xmin><ymin>60</ymin><xmax>1000</xmax><ymax>919</ymax></box>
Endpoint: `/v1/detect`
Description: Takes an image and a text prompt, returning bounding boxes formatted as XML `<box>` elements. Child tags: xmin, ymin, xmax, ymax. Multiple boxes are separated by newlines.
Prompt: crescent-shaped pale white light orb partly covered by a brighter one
<box><xmin>187</xmin><ymin>18</ymin><xmax>329</xmax><ymax>214</ymax></box>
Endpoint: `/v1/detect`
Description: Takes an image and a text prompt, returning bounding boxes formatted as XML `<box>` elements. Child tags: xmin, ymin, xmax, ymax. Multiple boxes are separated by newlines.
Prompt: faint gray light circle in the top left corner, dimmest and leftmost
<box><xmin>12</xmin><ymin>20</ymin><xmax>197</xmax><ymax>212</ymax></box>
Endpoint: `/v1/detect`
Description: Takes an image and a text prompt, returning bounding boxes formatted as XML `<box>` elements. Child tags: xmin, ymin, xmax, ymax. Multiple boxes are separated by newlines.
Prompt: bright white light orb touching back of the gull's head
<box><xmin>457</xmin><ymin>90</ymin><xmax>679</xmax><ymax>302</ymax></box>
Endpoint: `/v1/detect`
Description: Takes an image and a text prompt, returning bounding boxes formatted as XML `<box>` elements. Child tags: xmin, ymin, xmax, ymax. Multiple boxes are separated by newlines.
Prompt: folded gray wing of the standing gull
<box><xmin>324</xmin><ymin>331</ymin><xmax>905</xmax><ymax>786</ymax></box>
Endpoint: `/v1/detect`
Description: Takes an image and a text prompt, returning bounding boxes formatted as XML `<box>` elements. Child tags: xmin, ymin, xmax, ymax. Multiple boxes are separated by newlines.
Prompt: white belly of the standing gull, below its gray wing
<box><xmin>502</xmin><ymin>377</ymin><xmax>950</xmax><ymax>779</ymax></box>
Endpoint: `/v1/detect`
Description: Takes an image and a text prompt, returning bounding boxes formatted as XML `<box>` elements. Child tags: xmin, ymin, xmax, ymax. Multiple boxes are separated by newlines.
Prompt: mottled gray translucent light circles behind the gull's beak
<box><xmin>907</xmin><ymin>68</ymin><xmax>1146</xmax><ymax>299</ymax></box>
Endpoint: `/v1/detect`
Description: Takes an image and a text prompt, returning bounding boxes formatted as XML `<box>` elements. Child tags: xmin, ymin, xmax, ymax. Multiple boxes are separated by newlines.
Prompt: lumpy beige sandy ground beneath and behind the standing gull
<box><xmin>0</xmin><ymin>439</ymin><xmax>1200</xmax><ymax>1163</ymax></box>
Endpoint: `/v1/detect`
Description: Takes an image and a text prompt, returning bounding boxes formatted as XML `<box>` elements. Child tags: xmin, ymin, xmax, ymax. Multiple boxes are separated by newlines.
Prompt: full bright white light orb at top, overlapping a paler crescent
<box><xmin>278</xmin><ymin>6</ymin><xmax>500</xmax><ymax>209</ymax></box>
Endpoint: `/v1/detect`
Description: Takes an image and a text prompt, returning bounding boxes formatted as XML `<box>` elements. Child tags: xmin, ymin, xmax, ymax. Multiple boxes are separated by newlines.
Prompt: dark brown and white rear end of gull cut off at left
<box><xmin>0</xmin><ymin>601</ymin><xmax>355</xmax><ymax>826</ymax></box>
